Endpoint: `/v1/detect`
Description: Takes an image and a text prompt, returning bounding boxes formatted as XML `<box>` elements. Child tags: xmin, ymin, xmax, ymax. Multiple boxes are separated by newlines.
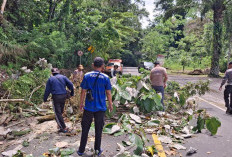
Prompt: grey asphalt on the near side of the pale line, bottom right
<box><xmin>177</xmin><ymin>99</ymin><xmax>232</xmax><ymax>157</ymax></box>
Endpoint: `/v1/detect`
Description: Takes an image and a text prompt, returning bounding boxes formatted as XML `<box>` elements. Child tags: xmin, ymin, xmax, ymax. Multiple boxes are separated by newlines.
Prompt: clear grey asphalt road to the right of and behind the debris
<box><xmin>125</xmin><ymin>67</ymin><xmax>232</xmax><ymax>157</ymax></box>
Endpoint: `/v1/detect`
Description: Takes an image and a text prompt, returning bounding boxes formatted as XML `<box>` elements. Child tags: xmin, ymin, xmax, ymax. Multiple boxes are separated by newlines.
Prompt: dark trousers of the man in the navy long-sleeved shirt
<box><xmin>52</xmin><ymin>94</ymin><xmax>66</xmax><ymax>130</ymax></box>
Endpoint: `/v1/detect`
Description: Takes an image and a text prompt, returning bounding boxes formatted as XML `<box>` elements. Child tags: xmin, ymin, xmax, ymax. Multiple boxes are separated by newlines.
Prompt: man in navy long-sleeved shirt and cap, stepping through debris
<box><xmin>44</xmin><ymin>68</ymin><xmax>74</xmax><ymax>133</ymax></box>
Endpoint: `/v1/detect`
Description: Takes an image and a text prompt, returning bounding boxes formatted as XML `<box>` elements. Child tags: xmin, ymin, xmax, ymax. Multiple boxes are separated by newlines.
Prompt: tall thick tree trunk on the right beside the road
<box><xmin>209</xmin><ymin>0</ymin><xmax>225</xmax><ymax>77</ymax></box>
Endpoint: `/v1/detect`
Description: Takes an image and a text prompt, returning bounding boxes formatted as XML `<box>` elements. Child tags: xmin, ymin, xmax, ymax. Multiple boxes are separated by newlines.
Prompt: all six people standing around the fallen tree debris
<box><xmin>44</xmin><ymin>57</ymin><xmax>232</xmax><ymax>156</ymax></box>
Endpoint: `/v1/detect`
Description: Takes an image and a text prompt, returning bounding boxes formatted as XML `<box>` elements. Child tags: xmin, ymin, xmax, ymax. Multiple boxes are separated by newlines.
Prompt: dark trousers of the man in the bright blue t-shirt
<box><xmin>79</xmin><ymin>110</ymin><xmax>105</xmax><ymax>153</ymax></box>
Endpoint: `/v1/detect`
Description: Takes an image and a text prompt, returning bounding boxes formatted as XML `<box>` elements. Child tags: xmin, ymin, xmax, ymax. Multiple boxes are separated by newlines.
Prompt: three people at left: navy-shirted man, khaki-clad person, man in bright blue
<box><xmin>44</xmin><ymin>57</ymin><xmax>113</xmax><ymax>156</ymax></box>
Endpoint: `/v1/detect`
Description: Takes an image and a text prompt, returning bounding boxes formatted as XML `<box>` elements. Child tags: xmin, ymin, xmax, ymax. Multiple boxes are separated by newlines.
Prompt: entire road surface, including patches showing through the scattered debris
<box><xmin>3</xmin><ymin>67</ymin><xmax>232</xmax><ymax>157</ymax></box>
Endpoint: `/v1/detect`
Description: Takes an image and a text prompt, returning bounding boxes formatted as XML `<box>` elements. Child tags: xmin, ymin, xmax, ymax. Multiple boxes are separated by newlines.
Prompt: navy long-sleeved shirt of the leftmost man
<box><xmin>44</xmin><ymin>74</ymin><xmax>74</xmax><ymax>102</ymax></box>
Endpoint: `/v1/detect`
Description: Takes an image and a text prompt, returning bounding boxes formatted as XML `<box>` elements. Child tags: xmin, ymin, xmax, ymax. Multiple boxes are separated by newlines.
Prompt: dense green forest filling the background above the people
<box><xmin>0</xmin><ymin>0</ymin><xmax>232</xmax><ymax>76</ymax></box>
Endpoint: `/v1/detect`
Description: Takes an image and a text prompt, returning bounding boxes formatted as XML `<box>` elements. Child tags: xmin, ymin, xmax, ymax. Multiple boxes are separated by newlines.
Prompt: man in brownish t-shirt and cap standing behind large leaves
<box><xmin>150</xmin><ymin>61</ymin><xmax>168</xmax><ymax>108</ymax></box>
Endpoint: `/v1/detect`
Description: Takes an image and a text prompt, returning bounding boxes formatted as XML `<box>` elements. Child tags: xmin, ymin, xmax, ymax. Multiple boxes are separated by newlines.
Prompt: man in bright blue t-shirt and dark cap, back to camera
<box><xmin>77</xmin><ymin>57</ymin><xmax>112</xmax><ymax>156</ymax></box>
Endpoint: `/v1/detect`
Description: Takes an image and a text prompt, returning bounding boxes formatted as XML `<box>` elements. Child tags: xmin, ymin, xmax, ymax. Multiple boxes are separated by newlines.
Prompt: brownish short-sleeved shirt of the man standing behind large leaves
<box><xmin>151</xmin><ymin>67</ymin><xmax>167</xmax><ymax>86</ymax></box>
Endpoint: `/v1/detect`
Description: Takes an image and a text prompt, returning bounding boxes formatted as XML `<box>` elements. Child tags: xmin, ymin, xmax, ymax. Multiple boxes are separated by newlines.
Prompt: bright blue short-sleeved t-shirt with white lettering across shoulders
<box><xmin>81</xmin><ymin>71</ymin><xmax>111</xmax><ymax>112</ymax></box>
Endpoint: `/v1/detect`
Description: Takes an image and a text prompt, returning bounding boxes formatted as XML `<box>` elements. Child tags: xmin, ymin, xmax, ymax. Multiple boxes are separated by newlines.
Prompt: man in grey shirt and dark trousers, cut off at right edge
<box><xmin>219</xmin><ymin>62</ymin><xmax>232</xmax><ymax>114</ymax></box>
